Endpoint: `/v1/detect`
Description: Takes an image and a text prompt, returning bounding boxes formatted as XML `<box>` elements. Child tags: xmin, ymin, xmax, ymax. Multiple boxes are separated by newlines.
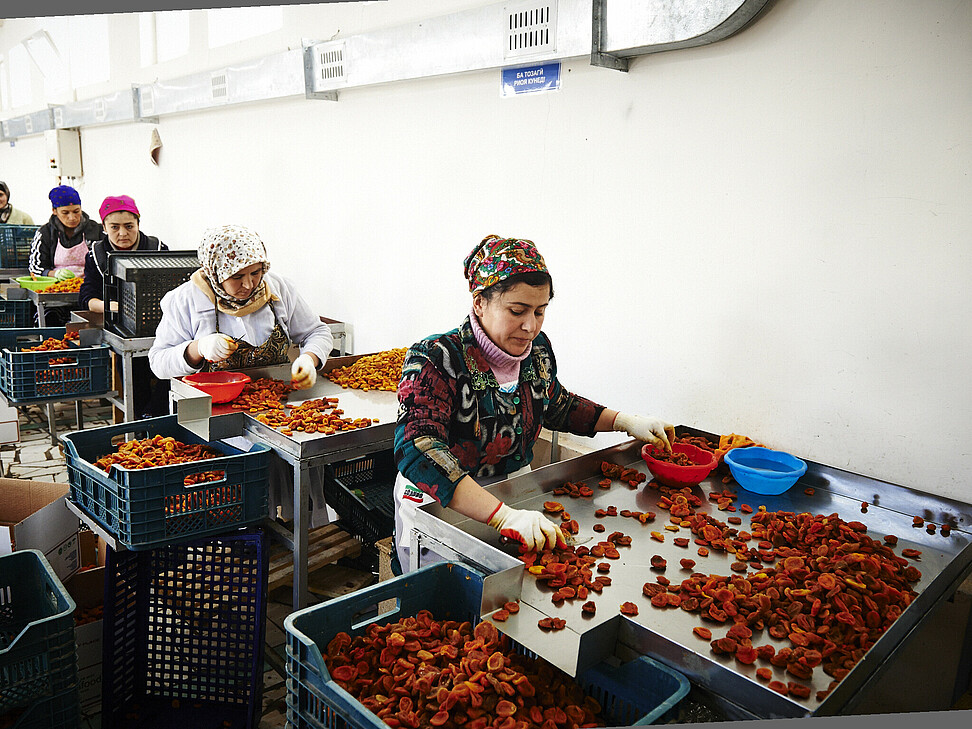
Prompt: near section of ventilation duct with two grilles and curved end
<box><xmin>305</xmin><ymin>0</ymin><xmax>768</xmax><ymax>98</ymax></box>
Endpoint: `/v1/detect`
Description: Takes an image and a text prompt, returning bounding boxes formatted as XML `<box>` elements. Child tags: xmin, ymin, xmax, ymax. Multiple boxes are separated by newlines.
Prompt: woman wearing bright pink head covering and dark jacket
<box><xmin>78</xmin><ymin>195</ymin><xmax>169</xmax><ymax>417</ymax></box>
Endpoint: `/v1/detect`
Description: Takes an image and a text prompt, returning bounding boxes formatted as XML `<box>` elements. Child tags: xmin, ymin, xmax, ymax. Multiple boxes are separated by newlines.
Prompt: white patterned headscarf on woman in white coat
<box><xmin>198</xmin><ymin>225</ymin><xmax>270</xmax><ymax>313</ymax></box>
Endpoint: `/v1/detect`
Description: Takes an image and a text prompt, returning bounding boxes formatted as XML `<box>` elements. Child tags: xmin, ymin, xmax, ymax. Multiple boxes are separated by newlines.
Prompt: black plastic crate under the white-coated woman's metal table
<box><xmin>324</xmin><ymin>450</ymin><xmax>398</xmax><ymax>544</ymax></box>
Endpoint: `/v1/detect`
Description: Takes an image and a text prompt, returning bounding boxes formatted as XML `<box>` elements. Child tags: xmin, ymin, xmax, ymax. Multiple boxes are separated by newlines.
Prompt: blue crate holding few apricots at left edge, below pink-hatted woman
<box><xmin>0</xmin><ymin>327</ymin><xmax>111</xmax><ymax>404</ymax></box>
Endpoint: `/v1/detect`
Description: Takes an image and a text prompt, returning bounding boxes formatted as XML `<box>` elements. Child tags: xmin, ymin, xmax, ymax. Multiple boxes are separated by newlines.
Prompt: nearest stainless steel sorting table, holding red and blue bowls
<box><xmin>411</xmin><ymin>429</ymin><xmax>972</xmax><ymax>719</ymax></box>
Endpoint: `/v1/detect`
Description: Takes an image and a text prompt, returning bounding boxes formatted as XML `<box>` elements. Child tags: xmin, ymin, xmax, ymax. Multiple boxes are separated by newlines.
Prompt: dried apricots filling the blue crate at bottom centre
<box><xmin>325</xmin><ymin>610</ymin><xmax>603</xmax><ymax>729</ymax></box>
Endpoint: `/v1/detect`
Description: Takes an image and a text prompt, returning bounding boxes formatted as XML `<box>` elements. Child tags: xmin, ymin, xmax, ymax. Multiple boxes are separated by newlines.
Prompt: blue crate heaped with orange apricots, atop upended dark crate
<box><xmin>62</xmin><ymin>415</ymin><xmax>270</xmax><ymax>550</ymax></box>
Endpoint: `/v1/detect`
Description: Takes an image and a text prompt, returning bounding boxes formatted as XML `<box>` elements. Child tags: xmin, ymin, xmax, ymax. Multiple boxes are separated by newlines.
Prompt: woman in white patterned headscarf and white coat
<box><xmin>149</xmin><ymin>225</ymin><xmax>332</xmax><ymax>526</ymax></box>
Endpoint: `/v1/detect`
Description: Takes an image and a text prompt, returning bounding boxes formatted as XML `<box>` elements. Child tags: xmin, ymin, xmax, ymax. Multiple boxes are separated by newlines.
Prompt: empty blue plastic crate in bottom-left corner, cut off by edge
<box><xmin>0</xmin><ymin>549</ymin><xmax>78</xmax><ymax>726</ymax></box>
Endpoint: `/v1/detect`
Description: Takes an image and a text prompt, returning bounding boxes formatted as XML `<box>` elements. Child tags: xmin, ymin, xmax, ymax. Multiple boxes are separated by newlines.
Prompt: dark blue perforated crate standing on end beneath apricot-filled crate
<box><xmin>101</xmin><ymin>529</ymin><xmax>269</xmax><ymax>729</ymax></box>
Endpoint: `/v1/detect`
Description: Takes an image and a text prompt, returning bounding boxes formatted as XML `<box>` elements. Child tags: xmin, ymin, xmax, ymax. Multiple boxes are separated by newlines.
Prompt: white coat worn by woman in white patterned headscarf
<box><xmin>149</xmin><ymin>271</ymin><xmax>332</xmax><ymax>527</ymax></box>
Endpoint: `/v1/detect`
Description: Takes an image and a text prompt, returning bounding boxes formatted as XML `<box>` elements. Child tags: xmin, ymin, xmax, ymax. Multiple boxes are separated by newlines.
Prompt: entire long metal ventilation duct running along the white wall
<box><xmin>2</xmin><ymin>0</ymin><xmax>768</xmax><ymax>139</ymax></box>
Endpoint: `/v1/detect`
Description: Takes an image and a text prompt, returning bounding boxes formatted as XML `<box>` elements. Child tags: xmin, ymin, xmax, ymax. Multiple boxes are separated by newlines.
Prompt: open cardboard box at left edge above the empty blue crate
<box><xmin>0</xmin><ymin>478</ymin><xmax>81</xmax><ymax>582</ymax></box>
